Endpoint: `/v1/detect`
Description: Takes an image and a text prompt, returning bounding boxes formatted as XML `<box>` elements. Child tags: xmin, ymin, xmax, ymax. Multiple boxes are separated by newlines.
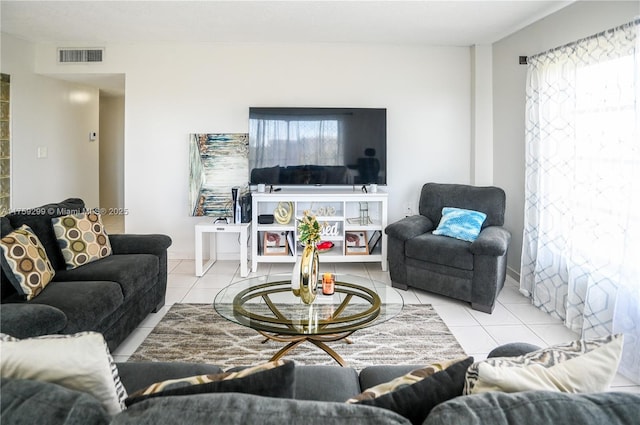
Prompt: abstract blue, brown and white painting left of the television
<box><xmin>189</xmin><ymin>133</ymin><xmax>249</xmax><ymax>217</ymax></box>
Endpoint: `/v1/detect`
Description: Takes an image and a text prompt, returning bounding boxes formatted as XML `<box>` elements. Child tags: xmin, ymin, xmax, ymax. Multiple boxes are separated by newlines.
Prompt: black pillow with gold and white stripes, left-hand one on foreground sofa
<box><xmin>125</xmin><ymin>360</ymin><xmax>295</xmax><ymax>406</ymax></box>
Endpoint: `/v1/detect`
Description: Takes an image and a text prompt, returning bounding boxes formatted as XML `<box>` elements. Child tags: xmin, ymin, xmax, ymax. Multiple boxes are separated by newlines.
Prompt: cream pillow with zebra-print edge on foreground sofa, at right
<box><xmin>464</xmin><ymin>334</ymin><xmax>624</xmax><ymax>394</ymax></box>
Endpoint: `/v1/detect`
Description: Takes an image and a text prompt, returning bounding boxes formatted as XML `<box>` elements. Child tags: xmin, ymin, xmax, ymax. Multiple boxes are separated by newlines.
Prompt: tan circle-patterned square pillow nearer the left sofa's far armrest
<box><xmin>51</xmin><ymin>213</ymin><xmax>111</xmax><ymax>270</ymax></box>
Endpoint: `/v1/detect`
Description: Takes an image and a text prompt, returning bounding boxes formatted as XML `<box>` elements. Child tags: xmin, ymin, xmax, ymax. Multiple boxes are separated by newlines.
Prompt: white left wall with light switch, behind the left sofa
<box><xmin>0</xmin><ymin>34</ymin><xmax>99</xmax><ymax>209</ymax></box>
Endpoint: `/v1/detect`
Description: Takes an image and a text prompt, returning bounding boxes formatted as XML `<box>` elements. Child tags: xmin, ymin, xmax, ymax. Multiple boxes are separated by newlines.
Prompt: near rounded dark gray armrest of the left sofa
<box><xmin>0</xmin><ymin>303</ymin><xmax>67</xmax><ymax>339</ymax></box>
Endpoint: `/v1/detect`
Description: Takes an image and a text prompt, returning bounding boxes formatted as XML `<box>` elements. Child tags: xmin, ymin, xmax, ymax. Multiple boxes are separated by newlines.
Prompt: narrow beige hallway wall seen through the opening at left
<box><xmin>99</xmin><ymin>93</ymin><xmax>125</xmax><ymax>209</ymax></box>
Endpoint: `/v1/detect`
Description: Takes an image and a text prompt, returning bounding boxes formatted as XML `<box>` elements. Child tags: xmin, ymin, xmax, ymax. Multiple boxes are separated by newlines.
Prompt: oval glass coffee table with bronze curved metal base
<box><xmin>213</xmin><ymin>274</ymin><xmax>404</xmax><ymax>366</ymax></box>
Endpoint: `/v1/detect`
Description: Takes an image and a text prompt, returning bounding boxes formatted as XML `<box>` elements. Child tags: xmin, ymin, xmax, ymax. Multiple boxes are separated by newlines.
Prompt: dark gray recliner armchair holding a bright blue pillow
<box><xmin>385</xmin><ymin>183</ymin><xmax>511</xmax><ymax>313</ymax></box>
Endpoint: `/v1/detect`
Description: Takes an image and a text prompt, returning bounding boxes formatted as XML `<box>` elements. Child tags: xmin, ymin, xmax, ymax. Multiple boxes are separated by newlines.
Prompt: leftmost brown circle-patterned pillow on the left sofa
<box><xmin>0</xmin><ymin>224</ymin><xmax>55</xmax><ymax>300</ymax></box>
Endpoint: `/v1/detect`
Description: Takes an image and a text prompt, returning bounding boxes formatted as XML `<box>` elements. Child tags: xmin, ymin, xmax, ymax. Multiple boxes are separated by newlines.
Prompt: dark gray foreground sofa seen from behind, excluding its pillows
<box><xmin>0</xmin><ymin>354</ymin><xmax>640</xmax><ymax>425</ymax></box>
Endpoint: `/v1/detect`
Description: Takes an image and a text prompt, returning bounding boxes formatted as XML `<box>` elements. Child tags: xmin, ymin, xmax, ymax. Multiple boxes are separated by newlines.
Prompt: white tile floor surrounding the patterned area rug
<box><xmin>113</xmin><ymin>255</ymin><xmax>640</xmax><ymax>393</ymax></box>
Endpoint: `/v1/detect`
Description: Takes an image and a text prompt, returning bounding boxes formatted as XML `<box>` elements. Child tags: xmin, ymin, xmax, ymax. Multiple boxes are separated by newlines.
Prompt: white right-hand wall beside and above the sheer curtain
<box><xmin>493</xmin><ymin>1</ymin><xmax>640</xmax><ymax>277</ymax></box>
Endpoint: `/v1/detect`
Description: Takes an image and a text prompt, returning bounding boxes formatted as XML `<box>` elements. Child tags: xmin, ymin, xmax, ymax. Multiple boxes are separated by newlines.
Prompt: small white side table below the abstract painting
<box><xmin>196</xmin><ymin>222</ymin><xmax>251</xmax><ymax>277</ymax></box>
